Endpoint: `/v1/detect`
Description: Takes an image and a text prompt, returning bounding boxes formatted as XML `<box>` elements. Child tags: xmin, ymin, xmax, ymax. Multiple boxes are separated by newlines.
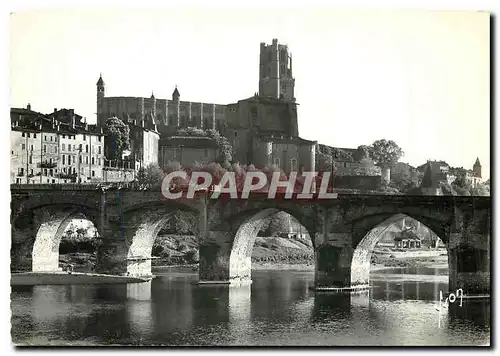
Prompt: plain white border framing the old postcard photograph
<box><xmin>0</xmin><ymin>0</ymin><xmax>500</xmax><ymax>355</ymax></box>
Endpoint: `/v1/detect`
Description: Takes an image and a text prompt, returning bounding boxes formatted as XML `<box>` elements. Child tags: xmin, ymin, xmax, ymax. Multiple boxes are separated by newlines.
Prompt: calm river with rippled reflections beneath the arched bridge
<box><xmin>11</xmin><ymin>268</ymin><xmax>490</xmax><ymax>346</ymax></box>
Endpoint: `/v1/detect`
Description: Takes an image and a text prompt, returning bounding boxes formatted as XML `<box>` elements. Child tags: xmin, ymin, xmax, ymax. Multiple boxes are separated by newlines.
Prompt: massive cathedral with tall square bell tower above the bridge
<box><xmin>97</xmin><ymin>39</ymin><xmax>317</xmax><ymax>173</ymax></box>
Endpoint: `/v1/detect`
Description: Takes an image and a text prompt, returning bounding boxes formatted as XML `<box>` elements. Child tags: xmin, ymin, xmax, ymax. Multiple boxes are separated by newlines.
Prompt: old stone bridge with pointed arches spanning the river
<box><xmin>11</xmin><ymin>185</ymin><xmax>491</xmax><ymax>295</ymax></box>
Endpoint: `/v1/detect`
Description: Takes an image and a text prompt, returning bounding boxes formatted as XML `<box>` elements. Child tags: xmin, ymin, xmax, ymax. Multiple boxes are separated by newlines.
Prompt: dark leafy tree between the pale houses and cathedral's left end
<box><xmin>104</xmin><ymin>117</ymin><xmax>130</xmax><ymax>160</ymax></box>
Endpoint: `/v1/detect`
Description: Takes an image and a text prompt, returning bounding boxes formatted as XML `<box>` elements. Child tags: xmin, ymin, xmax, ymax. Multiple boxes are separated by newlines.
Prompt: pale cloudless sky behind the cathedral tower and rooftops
<box><xmin>9</xmin><ymin>9</ymin><xmax>490</xmax><ymax>179</ymax></box>
